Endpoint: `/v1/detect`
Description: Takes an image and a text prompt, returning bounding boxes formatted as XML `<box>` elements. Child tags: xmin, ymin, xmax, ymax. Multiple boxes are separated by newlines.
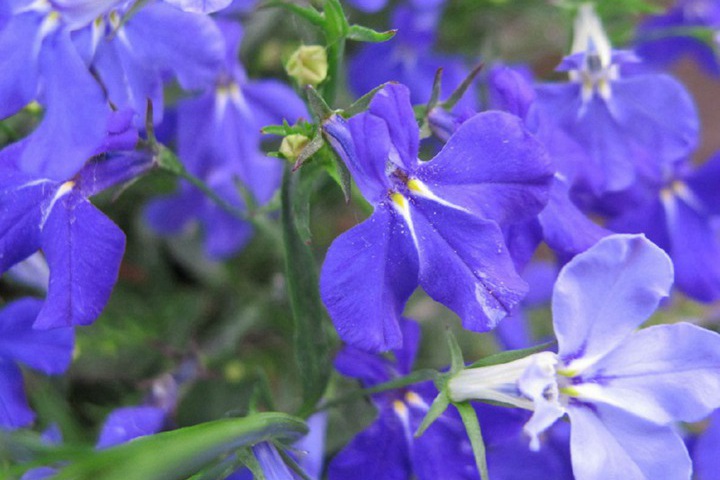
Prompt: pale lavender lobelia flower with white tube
<box><xmin>449</xmin><ymin>235</ymin><xmax>720</xmax><ymax>480</ymax></box>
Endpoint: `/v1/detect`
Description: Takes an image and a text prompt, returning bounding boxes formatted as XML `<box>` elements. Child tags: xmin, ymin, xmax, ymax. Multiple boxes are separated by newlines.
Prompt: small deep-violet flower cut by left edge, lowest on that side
<box><xmin>0</xmin><ymin>298</ymin><xmax>75</xmax><ymax>430</ymax></box>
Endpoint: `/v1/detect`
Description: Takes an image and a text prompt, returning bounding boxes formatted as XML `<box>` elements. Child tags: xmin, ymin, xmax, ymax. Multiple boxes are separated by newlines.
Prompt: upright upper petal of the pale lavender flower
<box><xmin>552</xmin><ymin>235</ymin><xmax>673</xmax><ymax>369</ymax></box>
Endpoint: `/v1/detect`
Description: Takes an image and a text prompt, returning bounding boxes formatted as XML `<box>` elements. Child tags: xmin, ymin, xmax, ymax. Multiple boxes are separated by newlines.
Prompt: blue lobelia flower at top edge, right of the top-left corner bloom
<box><xmin>73</xmin><ymin>0</ymin><xmax>224</xmax><ymax>127</ymax></box>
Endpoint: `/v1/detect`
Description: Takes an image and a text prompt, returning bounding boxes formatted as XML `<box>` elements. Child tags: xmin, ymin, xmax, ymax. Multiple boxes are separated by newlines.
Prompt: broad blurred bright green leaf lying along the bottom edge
<box><xmin>53</xmin><ymin>413</ymin><xmax>307</xmax><ymax>480</ymax></box>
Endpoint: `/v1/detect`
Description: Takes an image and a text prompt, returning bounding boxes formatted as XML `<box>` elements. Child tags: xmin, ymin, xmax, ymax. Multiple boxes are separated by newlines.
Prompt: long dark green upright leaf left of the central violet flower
<box><xmin>281</xmin><ymin>166</ymin><xmax>331</xmax><ymax>415</ymax></box>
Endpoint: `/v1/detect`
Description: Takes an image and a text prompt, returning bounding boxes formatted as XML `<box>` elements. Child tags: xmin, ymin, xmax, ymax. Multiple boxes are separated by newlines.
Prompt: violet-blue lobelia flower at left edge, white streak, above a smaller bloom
<box><xmin>0</xmin><ymin>117</ymin><xmax>152</xmax><ymax>329</ymax></box>
